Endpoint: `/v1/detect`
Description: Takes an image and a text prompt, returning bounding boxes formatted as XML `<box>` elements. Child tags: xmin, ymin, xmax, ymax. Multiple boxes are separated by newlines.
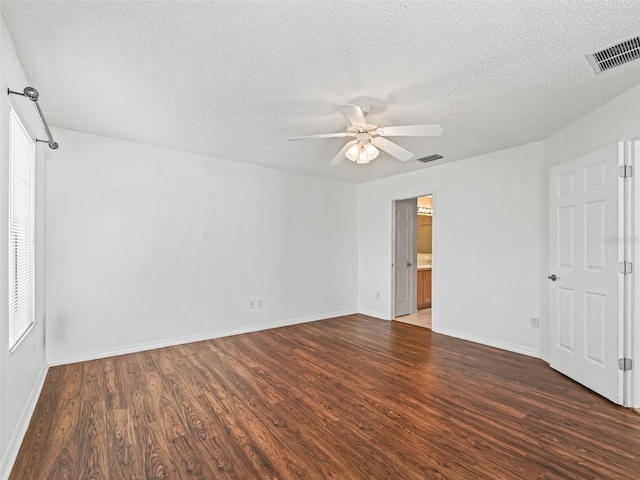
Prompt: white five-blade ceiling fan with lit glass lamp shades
<box><xmin>289</xmin><ymin>105</ymin><xmax>442</xmax><ymax>165</ymax></box>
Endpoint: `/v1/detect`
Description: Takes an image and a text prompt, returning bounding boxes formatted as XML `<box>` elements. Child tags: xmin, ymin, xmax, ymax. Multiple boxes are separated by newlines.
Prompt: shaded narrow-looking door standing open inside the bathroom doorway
<box><xmin>393</xmin><ymin>198</ymin><xmax>418</xmax><ymax>317</ymax></box>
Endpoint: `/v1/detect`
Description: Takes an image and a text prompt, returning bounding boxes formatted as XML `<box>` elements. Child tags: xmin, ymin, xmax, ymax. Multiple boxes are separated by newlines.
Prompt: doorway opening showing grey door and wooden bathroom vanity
<box><xmin>393</xmin><ymin>195</ymin><xmax>433</xmax><ymax>329</ymax></box>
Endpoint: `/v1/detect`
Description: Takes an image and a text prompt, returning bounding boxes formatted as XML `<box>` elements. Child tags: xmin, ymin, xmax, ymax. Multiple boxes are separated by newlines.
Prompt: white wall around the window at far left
<box><xmin>0</xmin><ymin>20</ymin><xmax>47</xmax><ymax>479</ymax></box>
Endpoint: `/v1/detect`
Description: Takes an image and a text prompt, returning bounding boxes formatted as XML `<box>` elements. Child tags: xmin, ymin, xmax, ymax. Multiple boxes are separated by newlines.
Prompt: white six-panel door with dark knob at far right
<box><xmin>549</xmin><ymin>144</ymin><xmax>624</xmax><ymax>404</ymax></box>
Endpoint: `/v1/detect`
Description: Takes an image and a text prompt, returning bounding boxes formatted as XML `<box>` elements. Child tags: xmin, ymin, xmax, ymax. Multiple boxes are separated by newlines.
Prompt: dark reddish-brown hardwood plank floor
<box><xmin>11</xmin><ymin>315</ymin><xmax>640</xmax><ymax>480</ymax></box>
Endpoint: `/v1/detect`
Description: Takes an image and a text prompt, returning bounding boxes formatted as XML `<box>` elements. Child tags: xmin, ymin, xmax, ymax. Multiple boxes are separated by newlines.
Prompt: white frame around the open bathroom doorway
<box><xmin>388</xmin><ymin>188</ymin><xmax>438</xmax><ymax>331</ymax></box>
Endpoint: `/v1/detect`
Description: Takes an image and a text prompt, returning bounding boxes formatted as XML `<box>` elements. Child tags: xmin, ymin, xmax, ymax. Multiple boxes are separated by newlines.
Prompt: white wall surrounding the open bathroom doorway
<box><xmin>358</xmin><ymin>143</ymin><xmax>547</xmax><ymax>356</ymax></box>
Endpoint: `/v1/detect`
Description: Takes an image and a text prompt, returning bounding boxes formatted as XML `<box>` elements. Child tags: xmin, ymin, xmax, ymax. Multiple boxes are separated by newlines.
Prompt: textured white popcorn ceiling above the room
<box><xmin>2</xmin><ymin>0</ymin><xmax>640</xmax><ymax>182</ymax></box>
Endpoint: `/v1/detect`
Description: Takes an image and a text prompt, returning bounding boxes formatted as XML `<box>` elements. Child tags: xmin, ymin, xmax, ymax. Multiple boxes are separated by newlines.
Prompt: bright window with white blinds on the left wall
<box><xmin>9</xmin><ymin>108</ymin><xmax>35</xmax><ymax>351</ymax></box>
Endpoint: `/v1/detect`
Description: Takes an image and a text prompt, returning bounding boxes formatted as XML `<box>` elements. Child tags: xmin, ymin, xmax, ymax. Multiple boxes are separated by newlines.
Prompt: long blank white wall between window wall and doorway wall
<box><xmin>47</xmin><ymin>129</ymin><xmax>357</xmax><ymax>364</ymax></box>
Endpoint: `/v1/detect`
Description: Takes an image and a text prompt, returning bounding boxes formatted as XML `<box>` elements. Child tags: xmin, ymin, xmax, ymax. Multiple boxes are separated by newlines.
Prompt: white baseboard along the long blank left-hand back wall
<box><xmin>47</xmin><ymin>310</ymin><xmax>357</xmax><ymax>367</ymax></box>
